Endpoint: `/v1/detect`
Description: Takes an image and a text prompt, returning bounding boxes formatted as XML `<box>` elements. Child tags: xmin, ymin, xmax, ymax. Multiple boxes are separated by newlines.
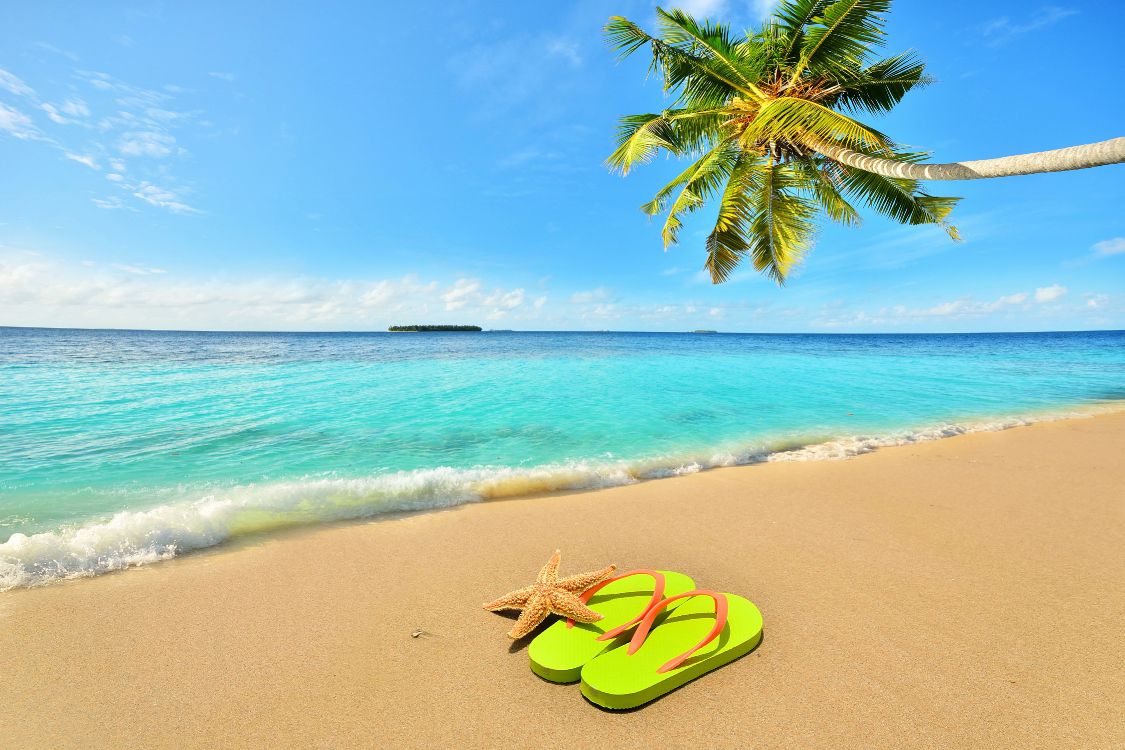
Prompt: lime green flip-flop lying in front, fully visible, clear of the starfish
<box><xmin>582</xmin><ymin>589</ymin><xmax>762</xmax><ymax>708</ymax></box>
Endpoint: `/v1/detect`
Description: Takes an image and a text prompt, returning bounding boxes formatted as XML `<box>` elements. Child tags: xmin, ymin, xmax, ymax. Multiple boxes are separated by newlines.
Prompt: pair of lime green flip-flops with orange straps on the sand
<box><xmin>528</xmin><ymin>569</ymin><xmax>762</xmax><ymax>708</ymax></box>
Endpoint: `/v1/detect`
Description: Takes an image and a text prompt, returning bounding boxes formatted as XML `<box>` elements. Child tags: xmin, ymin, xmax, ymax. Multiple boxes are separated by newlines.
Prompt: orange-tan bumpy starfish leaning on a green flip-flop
<box><xmin>484</xmin><ymin>550</ymin><xmax>618</xmax><ymax>640</ymax></box>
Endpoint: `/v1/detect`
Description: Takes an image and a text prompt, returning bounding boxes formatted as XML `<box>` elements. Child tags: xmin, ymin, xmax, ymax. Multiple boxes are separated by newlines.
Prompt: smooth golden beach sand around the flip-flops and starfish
<box><xmin>0</xmin><ymin>414</ymin><xmax>1125</xmax><ymax>749</ymax></box>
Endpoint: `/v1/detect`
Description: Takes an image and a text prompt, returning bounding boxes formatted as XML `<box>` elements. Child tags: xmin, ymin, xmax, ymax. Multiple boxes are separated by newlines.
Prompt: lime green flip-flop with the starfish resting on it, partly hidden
<box><xmin>528</xmin><ymin>570</ymin><xmax>695</xmax><ymax>683</ymax></box>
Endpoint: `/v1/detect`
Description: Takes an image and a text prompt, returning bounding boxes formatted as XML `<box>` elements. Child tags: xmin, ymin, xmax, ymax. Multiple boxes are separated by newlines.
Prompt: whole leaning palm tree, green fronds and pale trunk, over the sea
<box><xmin>605</xmin><ymin>0</ymin><xmax>1125</xmax><ymax>283</ymax></box>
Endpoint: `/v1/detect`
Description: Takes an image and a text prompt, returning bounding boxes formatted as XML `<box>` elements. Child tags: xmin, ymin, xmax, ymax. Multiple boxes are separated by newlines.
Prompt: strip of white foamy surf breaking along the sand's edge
<box><xmin>0</xmin><ymin>405</ymin><xmax>1122</xmax><ymax>591</ymax></box>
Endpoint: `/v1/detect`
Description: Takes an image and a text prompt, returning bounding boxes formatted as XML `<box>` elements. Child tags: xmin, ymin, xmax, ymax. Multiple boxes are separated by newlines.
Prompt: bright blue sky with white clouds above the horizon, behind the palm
<box><xmin>0</xmin><ymin>0</ymin><xmax>1125</xmax><ymax>332</ymax></box>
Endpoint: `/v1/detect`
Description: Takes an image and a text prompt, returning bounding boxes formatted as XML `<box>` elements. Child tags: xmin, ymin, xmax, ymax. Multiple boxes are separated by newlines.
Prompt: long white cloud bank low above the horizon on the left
<box><xmin>0</xmin><ymin>253</ymin><xmax>546</xmax><ymax>329</ymax></box>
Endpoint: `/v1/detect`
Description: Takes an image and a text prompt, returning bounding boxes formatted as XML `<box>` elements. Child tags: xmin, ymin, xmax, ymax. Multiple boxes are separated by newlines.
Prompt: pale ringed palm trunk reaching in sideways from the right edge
<box><xmin>809</xmin><ymin>137</ymin><xmax>1125</xmax><ymax>180</ymax></box>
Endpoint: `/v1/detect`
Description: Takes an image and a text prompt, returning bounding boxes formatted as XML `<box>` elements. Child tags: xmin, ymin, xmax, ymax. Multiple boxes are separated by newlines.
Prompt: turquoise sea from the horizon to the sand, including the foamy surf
<box><xmin>0</xmin><ymin>328</ymin><xmax>1125</xmax><ymax>589</ymax></box>
